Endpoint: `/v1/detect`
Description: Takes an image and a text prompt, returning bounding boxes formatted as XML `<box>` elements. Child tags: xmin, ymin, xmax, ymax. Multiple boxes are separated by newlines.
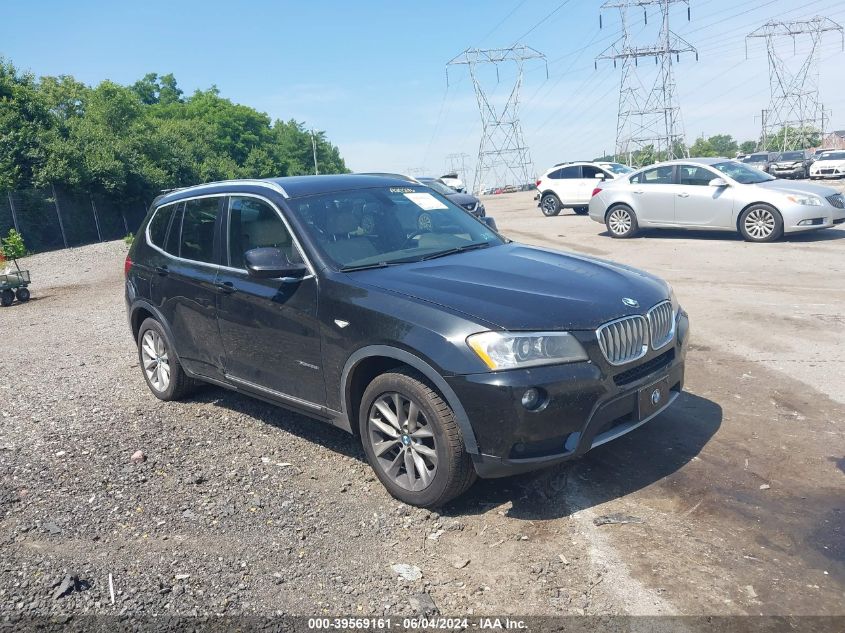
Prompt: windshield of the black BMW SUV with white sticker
<box><xmin>290</xmin><ymin>185</ymin><xmax>504</xmax><ymax>270</ymax></box>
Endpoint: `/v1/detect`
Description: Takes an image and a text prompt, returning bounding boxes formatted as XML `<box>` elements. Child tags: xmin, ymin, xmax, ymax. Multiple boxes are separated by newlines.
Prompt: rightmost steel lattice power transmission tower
<box><xmin>745</xmin><ymin>16</ymin><xmax>845</xmax><ymax>152</ymax></box>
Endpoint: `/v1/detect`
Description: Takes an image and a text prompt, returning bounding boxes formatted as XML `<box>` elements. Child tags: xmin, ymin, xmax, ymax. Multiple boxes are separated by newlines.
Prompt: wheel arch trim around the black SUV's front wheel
<box><xmin>340</xmin><ymin>345</ymin><xmax>478</xmax><ymax>454</ymax></box>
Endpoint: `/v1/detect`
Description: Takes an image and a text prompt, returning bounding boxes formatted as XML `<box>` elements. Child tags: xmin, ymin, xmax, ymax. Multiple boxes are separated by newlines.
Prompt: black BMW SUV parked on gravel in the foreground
<box><xmin>125</xmin><ymin>175</ymin><xmax>688</xmax><ymax>506</ymax></box>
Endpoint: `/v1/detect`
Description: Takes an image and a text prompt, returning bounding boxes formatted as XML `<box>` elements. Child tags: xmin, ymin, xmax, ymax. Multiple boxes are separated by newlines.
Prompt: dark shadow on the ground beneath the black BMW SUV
<box><xmin>191</xmin><ymin>386</ymin><xmax>722</xmax><ymax>520</ymax></box>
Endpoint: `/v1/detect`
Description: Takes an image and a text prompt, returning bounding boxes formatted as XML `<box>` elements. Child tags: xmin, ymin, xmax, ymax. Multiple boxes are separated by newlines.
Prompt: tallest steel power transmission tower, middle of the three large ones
<box><xmin>595</xmin><ymin>0</ymin><xmax>698</xmax><ymax>163</ymax></box>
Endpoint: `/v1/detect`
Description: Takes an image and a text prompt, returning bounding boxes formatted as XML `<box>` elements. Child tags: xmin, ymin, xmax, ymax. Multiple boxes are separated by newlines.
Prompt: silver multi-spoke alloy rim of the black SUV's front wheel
<box><xmin>367</xmin><ymin>391</ymin><xmax>437</xmax><ymax>491</ymax></box>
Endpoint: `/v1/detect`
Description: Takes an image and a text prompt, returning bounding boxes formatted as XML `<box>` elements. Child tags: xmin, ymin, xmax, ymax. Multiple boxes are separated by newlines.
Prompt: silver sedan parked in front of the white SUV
<box><xmin>590</xmin><ymin>158</ymin><xmax>845</xmax><ymax>242</ymax></box>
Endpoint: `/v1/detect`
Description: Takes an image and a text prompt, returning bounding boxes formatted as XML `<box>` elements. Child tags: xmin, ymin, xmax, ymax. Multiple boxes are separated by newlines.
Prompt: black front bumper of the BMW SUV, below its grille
<box><xmin>446</xmin><ymin>311</ymin><xmax>689</xmax><ymax>478</ymax></box>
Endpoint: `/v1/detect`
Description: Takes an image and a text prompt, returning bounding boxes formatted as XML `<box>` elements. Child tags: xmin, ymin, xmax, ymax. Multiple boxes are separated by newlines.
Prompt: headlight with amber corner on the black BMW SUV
<box><xmin>467</xmin><ymin>332</ymin><xmax>587</xmax><ymax>371</ymax></box>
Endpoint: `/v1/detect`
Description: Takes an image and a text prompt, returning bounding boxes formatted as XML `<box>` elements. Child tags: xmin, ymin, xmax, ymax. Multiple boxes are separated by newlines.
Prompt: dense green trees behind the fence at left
<box><xmin>0</xmin><ymin>58</ymin><xmax>348</xmax><ymax>201</ymax></box>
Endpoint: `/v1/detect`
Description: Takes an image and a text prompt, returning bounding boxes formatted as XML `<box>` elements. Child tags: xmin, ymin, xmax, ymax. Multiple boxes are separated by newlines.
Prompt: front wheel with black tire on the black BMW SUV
<box><xmin>358</xmin><ymin>371</ymin><xmax>475</xmax><ymax>508</ymax></box>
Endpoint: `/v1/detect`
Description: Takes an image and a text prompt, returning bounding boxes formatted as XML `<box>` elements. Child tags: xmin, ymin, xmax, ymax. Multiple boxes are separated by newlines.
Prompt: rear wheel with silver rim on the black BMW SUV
<box><xmin>138</xmin><ymin>319</ymin><xmax>195</xmax><ymax>401</ymax></box>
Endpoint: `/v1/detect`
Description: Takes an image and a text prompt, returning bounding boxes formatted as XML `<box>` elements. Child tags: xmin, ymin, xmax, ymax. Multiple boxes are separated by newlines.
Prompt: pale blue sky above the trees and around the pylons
<box><xmin>0</xmin><ymin>0</ymin><xmax>845</xmax><ymax>181</ymax></box>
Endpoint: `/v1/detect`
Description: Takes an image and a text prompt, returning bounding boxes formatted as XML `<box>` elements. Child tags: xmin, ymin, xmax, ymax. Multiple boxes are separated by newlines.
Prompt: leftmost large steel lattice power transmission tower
<box><xmin>446</xmin><ymin>44</ymin><xmax>549</xmax><ymax>193</ymax></box>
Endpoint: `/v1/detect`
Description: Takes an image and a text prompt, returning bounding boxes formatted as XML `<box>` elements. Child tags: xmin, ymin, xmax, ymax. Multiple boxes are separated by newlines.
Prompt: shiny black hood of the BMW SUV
<box><xmin>352</xmin><ymin>242</ymin><xmax>668</xmax><ymax>331</ymax></box>
